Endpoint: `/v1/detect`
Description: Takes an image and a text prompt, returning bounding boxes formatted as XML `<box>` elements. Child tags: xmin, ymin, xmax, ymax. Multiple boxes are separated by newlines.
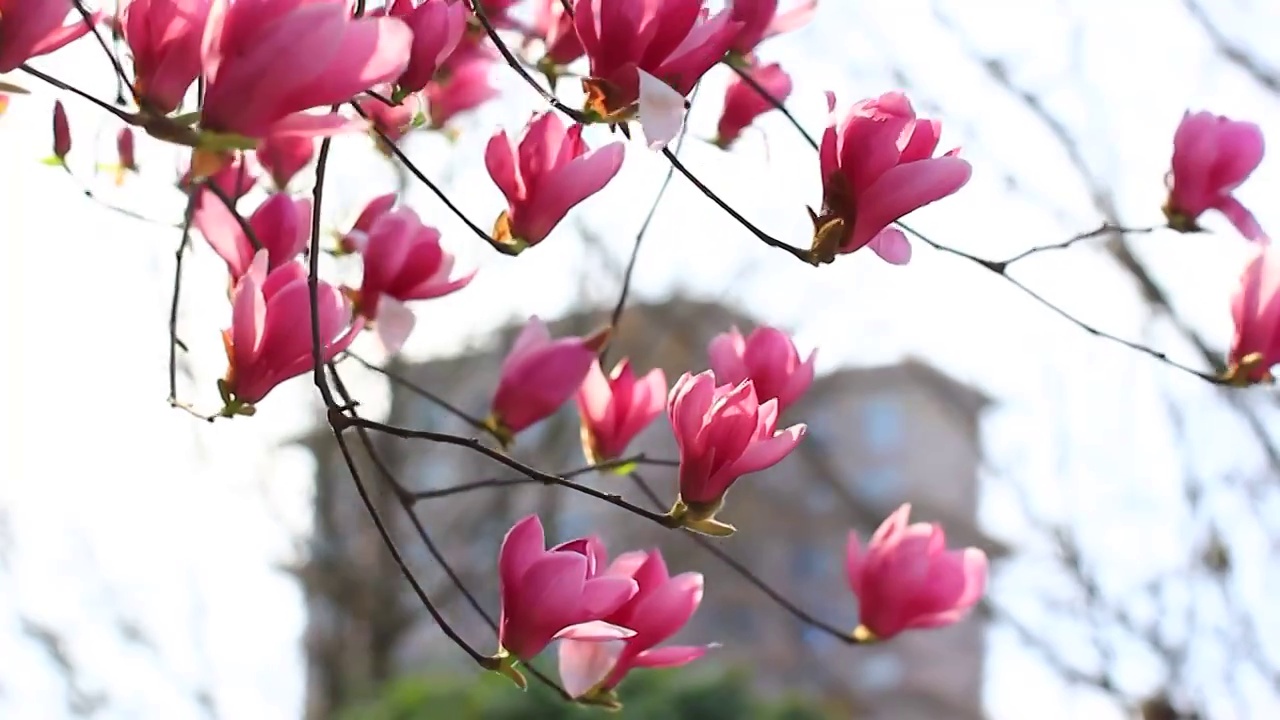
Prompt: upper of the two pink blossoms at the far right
<box><xmin>1165</xmin><ymin>113</ymin><xmax>1267</xmax><ymax>242</ymax></box>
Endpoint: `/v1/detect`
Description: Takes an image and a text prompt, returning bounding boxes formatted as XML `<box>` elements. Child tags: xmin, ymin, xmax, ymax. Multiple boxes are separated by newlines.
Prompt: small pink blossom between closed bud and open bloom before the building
<box><xmin>577</xmin><ymin>360</ymin><xmax>667</xmax><ymax>464</ymax></box>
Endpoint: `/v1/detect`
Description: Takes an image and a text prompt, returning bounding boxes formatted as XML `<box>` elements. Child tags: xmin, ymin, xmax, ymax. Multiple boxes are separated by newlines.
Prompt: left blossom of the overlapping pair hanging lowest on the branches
<box><xmin>498</xmin><ymin>515</ymin><xmax>640</xmax><ymax>661</ymax></box>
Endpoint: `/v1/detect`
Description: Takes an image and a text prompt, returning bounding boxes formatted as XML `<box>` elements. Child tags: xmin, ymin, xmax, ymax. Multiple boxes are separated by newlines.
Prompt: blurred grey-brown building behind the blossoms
<box><xmin>297</xmin><ymin>301</ymin><xmax>1004</xmax><ymax>720</ymax></box>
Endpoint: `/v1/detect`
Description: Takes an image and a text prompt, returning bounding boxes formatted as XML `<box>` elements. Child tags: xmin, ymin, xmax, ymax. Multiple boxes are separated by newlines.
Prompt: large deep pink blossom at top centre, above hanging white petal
<box><xmin>573</xmin><ymin>0</ymin><xmax>742</xmax><ymax>118</ymax></box>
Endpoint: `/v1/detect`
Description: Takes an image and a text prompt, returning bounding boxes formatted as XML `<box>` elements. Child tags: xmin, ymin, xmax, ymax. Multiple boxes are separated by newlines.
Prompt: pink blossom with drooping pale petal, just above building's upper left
<box><xmin>348</xmin><ymin>208</ymin><xmax>475</xmax><ymax>354</ymax></box>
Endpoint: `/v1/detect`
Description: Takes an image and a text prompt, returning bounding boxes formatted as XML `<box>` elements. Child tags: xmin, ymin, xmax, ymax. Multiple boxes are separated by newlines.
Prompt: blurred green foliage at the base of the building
<box><xmin>340</xmin><ymin>670</ymin><xmax>832</xmax><ymax>720</ymax></box>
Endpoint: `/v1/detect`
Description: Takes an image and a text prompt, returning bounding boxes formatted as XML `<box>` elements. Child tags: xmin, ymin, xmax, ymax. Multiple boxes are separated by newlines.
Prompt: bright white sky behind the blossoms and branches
<box><xmin>0</xmin><ymin>0</ymin><xmax>1280</xmax><ymax>720</ymax></box>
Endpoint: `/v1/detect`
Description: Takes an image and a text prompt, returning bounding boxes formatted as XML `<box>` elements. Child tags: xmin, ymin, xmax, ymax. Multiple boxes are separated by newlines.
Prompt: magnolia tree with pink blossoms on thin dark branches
<box><xmin>0</xmin><ymin>0</ymin><xmax>1280</xmax><ymax>706</ymax></box>
